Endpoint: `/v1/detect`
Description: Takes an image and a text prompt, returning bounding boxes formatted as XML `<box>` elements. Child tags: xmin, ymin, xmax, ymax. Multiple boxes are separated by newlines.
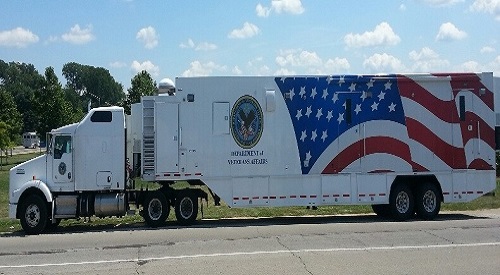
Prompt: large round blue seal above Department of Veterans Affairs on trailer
<box><xmin>231</xmin><ymin>95</ymin><xmax>264</xmax><ymax>149</ymax></box>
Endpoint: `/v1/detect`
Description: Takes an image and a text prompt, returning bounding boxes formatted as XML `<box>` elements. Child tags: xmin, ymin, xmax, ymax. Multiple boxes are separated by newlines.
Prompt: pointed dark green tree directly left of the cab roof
<box><xmin>35</xmin><ymin>67</ymin><xmax>79</xmax><ymax>140</ymax></box>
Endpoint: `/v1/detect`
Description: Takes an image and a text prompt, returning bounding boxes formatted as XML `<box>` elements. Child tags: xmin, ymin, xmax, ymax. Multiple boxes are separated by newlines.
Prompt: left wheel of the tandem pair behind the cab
<box><xmin>143</xmin><ymin>191</ymin><xmax>170</xmax><ymax>227</ymax></box>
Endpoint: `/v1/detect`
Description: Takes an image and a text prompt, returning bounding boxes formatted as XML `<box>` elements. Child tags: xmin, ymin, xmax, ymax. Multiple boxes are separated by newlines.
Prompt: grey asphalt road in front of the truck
<box><xmin>0</xmin><ymin>210</ymin><xmax>500</xmax><ymax>275</ymax></box>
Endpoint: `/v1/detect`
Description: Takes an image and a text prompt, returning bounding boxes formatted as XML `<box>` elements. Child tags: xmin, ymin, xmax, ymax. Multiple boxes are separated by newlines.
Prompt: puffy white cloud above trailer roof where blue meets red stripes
<box><xmin>409</xmin><ymin>47</ymin><xmax>450</xmax><ymax>72</ymax></box>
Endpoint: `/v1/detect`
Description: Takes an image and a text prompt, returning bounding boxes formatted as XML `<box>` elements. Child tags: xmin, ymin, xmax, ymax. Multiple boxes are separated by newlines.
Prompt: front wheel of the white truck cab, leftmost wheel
<box><xmin>20</xmin><ymin>195</ymin><xmax>48</xmax><ymax>235</ymax></box>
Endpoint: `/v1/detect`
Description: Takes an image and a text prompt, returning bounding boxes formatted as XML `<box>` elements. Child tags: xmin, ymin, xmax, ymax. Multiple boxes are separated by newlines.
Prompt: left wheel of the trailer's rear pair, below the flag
<box><xmin>389</xmin><ymin>184</ymin><xmax>415</xmax><ymax>221</ymax></box>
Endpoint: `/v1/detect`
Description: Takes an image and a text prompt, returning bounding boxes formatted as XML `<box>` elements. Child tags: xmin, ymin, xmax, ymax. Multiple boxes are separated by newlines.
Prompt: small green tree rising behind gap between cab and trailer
<box><xmin>122</xmin><ymin>71</ymin><xmax>157</xmax><ymax>114</ymax></box>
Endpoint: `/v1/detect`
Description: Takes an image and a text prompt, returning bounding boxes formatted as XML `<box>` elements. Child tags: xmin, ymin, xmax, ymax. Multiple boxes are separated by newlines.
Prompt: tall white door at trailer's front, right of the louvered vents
<box><xmin>155</xmin><ymin>102</ymin><xmax>179</xmax><ymax>175</ymax></box>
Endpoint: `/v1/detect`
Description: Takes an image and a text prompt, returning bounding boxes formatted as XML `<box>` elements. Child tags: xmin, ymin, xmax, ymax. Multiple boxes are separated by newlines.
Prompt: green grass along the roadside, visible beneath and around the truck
<box><xmin>0</xmin><ymin>154</ymin><xmax>500</xmax><ymax>232</ymax></box>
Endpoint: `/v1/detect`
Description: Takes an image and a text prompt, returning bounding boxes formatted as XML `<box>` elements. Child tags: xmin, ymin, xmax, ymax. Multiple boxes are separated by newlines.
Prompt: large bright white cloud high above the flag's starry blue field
<box><xmin>344</xmin><ymin>22</ymin><xmax>401</xmax><ymax>48</ymax></box>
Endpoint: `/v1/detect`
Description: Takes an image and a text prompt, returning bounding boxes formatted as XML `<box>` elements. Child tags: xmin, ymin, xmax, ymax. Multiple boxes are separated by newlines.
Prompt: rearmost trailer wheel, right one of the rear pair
<box><xmin>416</xmin><ymin>183</ymin><xmax>441</xmax><ymax>220</ymax></box>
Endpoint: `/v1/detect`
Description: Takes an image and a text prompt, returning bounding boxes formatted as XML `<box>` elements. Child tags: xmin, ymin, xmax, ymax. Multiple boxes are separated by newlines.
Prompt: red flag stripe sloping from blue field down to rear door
<box><xmin>406</xmin><ymin>117</ymin><xmax>467</xmax><ymax>169</ymax></box>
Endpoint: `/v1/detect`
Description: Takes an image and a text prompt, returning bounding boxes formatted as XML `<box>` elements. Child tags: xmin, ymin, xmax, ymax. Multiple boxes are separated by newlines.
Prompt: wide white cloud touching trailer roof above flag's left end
<box><xmin>275</xmin><ymin>49</ymin><xmax>351</xmax><ymax>74</ymax></box>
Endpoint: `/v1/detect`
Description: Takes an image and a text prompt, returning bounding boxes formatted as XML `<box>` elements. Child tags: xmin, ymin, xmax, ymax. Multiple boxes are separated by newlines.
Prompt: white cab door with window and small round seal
<box><xmin>52</xmin><ymin>135</ymin><xmax>73</xmax><ymax>183</ymax></box>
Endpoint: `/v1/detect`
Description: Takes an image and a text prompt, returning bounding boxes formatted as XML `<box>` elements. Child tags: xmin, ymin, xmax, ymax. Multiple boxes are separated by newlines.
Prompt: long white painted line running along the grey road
<box><xmin>0</xmin><ymin>242</ymin><xmax>500</xmax><ymax>269</ymax></box>
